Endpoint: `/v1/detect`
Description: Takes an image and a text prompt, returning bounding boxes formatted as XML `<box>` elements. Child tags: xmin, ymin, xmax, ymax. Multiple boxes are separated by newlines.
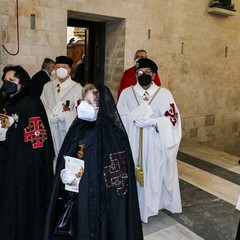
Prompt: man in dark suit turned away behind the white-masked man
<box><xmin>29</xmin><ymin>58</ymin><xmax>55</xmax><ymax>98</ymax></box>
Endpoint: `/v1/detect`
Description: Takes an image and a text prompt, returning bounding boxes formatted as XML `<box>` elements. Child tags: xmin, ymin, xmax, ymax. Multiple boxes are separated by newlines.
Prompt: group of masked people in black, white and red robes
<box><xmin>0</xmin><ymin>49</ymin><xmax>191</xmax><ymax>240</ymax></box>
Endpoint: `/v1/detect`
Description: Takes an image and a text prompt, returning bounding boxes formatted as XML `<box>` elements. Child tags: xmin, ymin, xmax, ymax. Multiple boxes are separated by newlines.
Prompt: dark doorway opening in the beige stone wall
<box><xmin>67</xmin><ymin>18</ymin><xmax>106</xmax><ymax>85</ymax></box>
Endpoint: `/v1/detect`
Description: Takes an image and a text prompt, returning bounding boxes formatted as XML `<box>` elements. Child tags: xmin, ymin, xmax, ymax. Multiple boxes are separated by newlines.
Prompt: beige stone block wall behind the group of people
<box><xmin>0</xmin><ymin>0</ymin><xmax>240</xmax><ymax>156</ymax></box>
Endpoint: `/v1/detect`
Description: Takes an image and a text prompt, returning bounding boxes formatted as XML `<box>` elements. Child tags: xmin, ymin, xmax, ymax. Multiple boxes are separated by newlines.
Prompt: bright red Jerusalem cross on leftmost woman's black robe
<box><xmin>24</xmin><ymin>117</ymin><xmax>47</xmax><ymax>148</ymax></box>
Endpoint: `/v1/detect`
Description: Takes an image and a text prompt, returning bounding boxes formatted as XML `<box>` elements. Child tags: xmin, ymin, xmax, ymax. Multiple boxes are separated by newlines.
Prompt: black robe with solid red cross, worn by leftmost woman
<box><xmin>0</xmin><ymin>90</ymin><xmax>54</xmax><ymax>240</ymax></box>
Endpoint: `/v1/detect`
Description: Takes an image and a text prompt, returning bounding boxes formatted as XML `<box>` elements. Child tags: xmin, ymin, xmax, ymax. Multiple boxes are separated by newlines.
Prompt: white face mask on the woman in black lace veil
<box><xmin>77</xmin><ymin>101</ymin><xmax>98</xmax><ymax>121</ymax></box>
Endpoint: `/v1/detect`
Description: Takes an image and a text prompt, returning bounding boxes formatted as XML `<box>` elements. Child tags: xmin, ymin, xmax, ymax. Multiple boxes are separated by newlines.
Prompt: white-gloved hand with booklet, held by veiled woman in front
<box><xmin>61</xmin><ymin>156</ymin><xmax>84</xmax><ymax>192</ymax></box>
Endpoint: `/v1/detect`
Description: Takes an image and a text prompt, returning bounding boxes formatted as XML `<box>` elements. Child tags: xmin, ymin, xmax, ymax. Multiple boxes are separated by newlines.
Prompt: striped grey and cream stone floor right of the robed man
<box><xmin>143</xmin><ymin>141</ymin><xmax>240</xmax><ymax>240</ymax></box>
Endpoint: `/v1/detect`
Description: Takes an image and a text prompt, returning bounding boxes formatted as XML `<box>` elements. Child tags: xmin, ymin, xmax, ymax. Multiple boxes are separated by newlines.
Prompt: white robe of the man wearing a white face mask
<box><xmin>41</xmin><ymin>77</ymin><xmax>82</xmax><ymax>163</ymax></box>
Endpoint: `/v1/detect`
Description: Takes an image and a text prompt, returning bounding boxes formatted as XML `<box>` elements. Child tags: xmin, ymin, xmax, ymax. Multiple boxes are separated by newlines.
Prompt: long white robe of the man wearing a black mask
<box><xmin>117</xmin><ymin>83</ymin><xmax>182</xmax><ymax>223</ymax></box>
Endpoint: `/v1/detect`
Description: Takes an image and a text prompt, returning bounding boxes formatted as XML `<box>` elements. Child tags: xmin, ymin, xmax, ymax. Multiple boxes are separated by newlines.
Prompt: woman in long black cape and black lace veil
<box><xmin>44</xmin><ymin>84</ymin><xmax>143</xmax><ymax>240</ymax></box>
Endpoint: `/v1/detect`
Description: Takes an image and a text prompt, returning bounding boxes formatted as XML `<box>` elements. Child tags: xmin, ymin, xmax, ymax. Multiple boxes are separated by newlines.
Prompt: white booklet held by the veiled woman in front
<box><xmin>64</xmin><ymin>156</ymin><xmax>84</xmax><ymax>192</ymax></box>
